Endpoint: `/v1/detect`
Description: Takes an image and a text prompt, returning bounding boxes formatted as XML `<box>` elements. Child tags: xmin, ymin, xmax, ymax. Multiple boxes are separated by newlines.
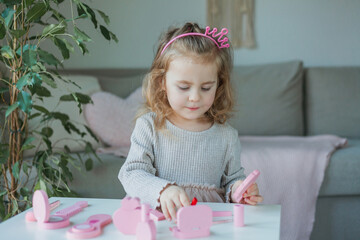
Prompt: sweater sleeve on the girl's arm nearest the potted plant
<box><xmin>118</xmin><ymin>117</ymin><xmax>174</xmax><ymax>209</ymax></box>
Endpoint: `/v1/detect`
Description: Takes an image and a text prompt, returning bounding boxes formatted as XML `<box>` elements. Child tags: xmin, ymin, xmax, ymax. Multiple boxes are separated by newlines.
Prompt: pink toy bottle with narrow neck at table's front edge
<box><xmin>136</xmin><ymin>204</ymin><xmax>156</xmax><ymax>240</ymax></box>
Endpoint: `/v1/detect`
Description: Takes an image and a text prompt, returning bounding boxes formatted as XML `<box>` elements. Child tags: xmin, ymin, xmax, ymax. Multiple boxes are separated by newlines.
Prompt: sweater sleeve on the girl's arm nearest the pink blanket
<box><xmin>221</xmin><ymin>132</ymin><xmax>246</xmax><ymax>202</ymax></box>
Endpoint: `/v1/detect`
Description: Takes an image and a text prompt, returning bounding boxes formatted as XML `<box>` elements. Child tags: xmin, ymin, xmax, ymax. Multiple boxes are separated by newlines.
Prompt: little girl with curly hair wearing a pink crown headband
<box><xmin>119</xmin><ymin>23</ymin><xmax>262</xmax><ymax>220</ymax></box>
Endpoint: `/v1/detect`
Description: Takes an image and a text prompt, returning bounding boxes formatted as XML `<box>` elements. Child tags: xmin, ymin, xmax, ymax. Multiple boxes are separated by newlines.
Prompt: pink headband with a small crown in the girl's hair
<box><xmin>160</xmin><ymin>26</ymin><xmax>230</xmax><ymax>55</ymax></box>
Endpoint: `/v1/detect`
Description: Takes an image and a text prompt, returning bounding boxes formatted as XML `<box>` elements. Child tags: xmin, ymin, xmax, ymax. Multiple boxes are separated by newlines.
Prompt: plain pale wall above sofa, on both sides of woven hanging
<box><xmin>45</xmin><ymin>0</ymin><xmax>360</xmax><ymax>68</ymax></box>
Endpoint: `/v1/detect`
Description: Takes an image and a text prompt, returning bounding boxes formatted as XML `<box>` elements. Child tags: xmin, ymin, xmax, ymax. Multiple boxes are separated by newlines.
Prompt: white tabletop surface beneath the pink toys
<box><xmin>0</xmin><ymin>198</ymin><xmax>281</xmax><ymax>240</ymax></box>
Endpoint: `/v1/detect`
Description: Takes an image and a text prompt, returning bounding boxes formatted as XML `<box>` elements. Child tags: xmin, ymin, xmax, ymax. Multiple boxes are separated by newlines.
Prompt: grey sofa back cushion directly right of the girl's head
<box><xmin>230</xmin><ymin>61</ymin><xmax>304</xmax><ymax>136</ymax></box>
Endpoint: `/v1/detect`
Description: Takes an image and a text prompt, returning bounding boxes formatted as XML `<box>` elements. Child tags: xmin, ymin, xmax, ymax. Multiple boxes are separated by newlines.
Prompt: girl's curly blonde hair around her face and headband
<box><xmin>136</xmin><ymin>23</ymin><xmax>234</xmax><ymax>130</ymax></box>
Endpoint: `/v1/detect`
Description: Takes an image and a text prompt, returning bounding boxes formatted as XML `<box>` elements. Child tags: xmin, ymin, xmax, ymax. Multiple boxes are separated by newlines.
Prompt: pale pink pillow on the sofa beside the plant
<box><xmin>84</xmin><ymin>87</ymin><xmax>143</xmax><ymax>148</ymax></box>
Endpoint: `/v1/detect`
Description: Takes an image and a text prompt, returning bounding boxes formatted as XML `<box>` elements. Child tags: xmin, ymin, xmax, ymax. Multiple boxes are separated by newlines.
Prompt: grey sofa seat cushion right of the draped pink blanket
<box><xmin>319</xmin><ymin>138</ymin><xmax>360</xmax><ymax>197</ymax></box>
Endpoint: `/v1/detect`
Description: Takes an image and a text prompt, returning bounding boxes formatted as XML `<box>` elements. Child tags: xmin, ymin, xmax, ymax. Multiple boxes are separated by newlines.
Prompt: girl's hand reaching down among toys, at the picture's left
<box><xmin>160</xmin><ymin>185</ymin><xmax>190</xmax><ymax>221</ymax></box>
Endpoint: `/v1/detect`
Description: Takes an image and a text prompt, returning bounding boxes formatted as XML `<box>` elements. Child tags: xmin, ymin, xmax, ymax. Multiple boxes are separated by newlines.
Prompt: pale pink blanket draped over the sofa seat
<box><xmin>240</xmin><ymin>135</ymin><xmax>346</xmax><ymax>240</ymax></box>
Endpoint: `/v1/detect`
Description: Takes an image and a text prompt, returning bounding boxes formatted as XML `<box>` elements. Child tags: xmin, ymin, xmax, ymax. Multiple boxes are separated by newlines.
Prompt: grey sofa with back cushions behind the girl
<box><xmin>2</xmin><ymin>61</ymin><xmax>360</xmax><ymax>239</ymax></box>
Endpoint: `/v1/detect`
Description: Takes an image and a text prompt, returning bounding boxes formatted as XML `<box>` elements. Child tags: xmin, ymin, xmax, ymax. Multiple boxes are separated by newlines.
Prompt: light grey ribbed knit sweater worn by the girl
<box><xmin>119</xmin><ymin>112</ymin><xmax>245</xmax><ymax>208</ymax></box>
